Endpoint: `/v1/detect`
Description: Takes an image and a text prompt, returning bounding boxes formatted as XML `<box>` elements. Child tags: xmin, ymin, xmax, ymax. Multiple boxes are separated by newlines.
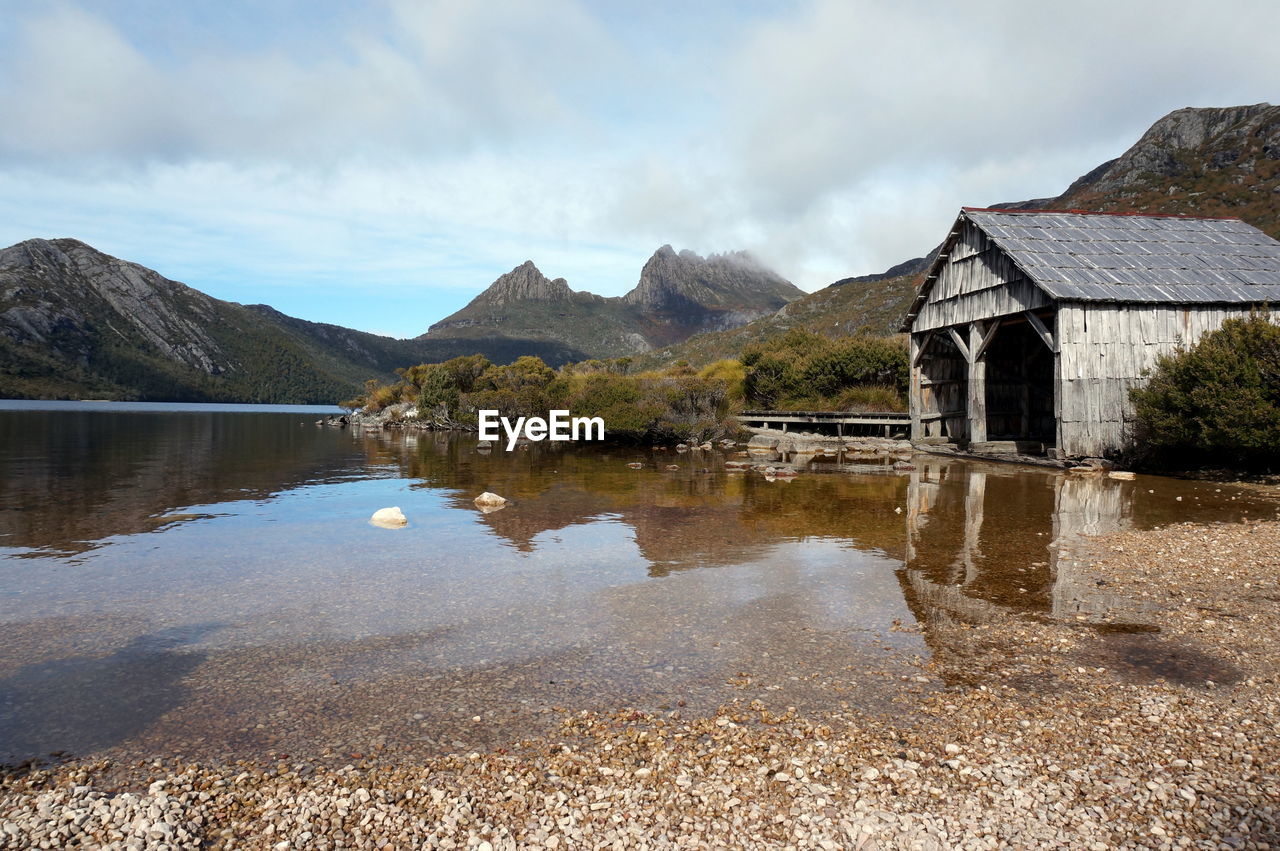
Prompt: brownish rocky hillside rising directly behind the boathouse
<box><xmin>641</xmin><ymin>104</ymin><xmax>1280</xmax><ymax>366</ymax></box>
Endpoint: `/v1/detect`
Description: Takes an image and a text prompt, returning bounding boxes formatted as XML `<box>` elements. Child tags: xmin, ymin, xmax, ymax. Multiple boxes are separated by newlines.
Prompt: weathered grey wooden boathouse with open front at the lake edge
<box><xmin>902</xmin><ymin>207</ymin><xmax>1280</xmax><ymax>458</ymax></box>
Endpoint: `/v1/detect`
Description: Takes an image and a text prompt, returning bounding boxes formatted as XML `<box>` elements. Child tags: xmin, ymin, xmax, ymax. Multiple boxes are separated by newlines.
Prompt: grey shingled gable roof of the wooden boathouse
<box><xmin>908</xmin><ymin>207</ymin><xmax>1280</xmax><ymax>332</ymax></box>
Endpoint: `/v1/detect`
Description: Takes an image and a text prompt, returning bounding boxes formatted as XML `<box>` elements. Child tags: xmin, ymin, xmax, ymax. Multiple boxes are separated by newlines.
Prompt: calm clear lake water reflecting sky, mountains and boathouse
<box><xmin>0</xmin><ymin>403</ymin><xmax>1276</xmax><ymax>761</ymax></box>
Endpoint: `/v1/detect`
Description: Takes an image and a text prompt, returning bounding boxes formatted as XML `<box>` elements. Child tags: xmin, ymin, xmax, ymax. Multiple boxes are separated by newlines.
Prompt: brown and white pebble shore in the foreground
<box><xmin>0</xmin><ymin>522</ymin><xmax>1280</xmax><ymax>851</ymax></box>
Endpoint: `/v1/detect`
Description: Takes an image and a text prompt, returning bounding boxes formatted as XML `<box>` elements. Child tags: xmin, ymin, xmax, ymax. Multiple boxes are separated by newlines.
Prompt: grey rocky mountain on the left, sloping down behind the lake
<box><xmin>0</xmin><ymin>239</ymin><xmax>580</xmax><ymax>403</ymax></box>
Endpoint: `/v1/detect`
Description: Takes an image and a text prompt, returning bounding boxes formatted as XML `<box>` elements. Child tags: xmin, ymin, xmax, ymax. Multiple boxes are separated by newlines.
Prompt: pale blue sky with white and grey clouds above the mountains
<box><xmin>0</xmin><ymin>0</ymin><xmax>1280</xmax><ymax>337</ymax></box>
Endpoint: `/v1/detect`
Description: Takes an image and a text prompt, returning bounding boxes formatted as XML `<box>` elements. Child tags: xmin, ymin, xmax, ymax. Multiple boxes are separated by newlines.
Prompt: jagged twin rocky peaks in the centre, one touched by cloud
<box><xmin>419</xmin><ymin>246</ymin><xmax>804</xmax><ymax>360</ymax></box>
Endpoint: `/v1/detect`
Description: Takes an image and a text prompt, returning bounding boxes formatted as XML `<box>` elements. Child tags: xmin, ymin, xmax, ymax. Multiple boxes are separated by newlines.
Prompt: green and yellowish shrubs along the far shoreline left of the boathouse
<box><xmin>343</xmin><ymin>329</ymin><xmax>906</xmax><ymax>441</ymax></box>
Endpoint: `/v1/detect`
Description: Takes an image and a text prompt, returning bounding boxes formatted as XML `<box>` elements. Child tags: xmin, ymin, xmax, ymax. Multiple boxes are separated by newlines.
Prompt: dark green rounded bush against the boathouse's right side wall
<box><xmin>1130</xmin><ymin>314</ymin><xmax>1280</xmax><ymax>467</ymax></box>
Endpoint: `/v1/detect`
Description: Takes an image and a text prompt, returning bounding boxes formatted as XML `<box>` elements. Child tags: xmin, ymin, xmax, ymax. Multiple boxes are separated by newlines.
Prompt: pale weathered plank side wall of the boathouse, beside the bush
<box><xmin>1056</xmin><ymin>302</ymin><xmax>1249</xmax><ymax>456</ymax></box>
